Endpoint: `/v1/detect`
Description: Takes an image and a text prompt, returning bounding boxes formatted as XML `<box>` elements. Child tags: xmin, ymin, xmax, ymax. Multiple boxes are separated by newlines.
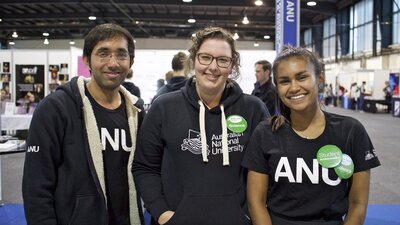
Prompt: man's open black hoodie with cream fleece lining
<box><xmin>22</xmin><ymin>77</ymin><xmax>144</xmax><ymax>225</ymax></box>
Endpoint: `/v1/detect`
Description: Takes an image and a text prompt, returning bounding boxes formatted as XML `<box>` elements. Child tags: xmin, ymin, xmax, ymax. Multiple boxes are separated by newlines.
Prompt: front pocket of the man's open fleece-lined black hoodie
<box><xmin>68</xmin><ymin>195</ymin><xmax>105</xmax><ymax>225</ymax></box>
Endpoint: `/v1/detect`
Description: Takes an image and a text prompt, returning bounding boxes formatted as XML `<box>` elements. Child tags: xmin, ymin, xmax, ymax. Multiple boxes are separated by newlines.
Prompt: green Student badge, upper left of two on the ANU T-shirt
<box><xmin>317</xmin><ymin>145</ymin><xmax>342</xmax><ymax>168</ymax></box>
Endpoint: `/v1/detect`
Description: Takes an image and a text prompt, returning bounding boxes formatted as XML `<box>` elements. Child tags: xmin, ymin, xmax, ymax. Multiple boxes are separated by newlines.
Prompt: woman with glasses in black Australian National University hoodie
<box><xmin>132</xmin><ymin>27</ymin><xmax>268</xmax><ymax>225</ymax></box>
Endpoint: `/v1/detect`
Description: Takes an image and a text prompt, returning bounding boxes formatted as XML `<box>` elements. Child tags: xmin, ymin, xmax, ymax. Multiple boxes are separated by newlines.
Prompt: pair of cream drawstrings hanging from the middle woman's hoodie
<box><xmin>198</xmin><ymin>100</ymin><xmax>229</xmax><ymax>166</ymax></box>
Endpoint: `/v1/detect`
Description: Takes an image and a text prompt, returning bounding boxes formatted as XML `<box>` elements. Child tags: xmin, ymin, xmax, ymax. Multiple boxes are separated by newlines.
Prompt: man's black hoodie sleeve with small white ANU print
<box><xmin>22</xmin><ymin>96</ymin><xmax>64</xmax><ymax>225</ymax></box>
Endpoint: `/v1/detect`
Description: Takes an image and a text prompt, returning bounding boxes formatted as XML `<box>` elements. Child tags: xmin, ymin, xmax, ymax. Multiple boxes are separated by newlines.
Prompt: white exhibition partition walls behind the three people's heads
<box><xmin>0</xmin><ymin>40</ymin><xmax>276</xmax><ymax>103</ymax></box>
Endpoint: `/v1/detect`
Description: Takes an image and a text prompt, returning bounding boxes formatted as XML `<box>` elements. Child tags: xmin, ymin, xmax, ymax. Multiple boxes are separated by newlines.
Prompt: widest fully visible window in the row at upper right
<box><xmin>350</xmin><ymin>0</ymin><xmax>376</xmax><ymax>53</ymax></box>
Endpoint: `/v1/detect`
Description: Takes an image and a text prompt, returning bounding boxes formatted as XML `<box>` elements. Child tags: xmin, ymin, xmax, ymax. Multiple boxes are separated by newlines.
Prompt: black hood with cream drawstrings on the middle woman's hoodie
<box><xmin>182</xmin><ymin>76</ymin><xmax>243</xmax><ymax>166</ymax></box>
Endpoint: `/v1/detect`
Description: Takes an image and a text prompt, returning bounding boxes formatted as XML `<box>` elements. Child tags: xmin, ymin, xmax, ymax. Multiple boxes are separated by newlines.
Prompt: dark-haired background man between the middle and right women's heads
<box><xmin>251</xmin><ymin>60</ymin><xmax>276</xmax><ymax>115</ymax></box>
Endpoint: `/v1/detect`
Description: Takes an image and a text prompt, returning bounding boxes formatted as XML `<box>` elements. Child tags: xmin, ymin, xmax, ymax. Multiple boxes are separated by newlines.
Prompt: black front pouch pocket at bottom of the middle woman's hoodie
<box><xmin>164</xmin><ymin>194</ymin><xmax>251</xmax><ymax>225</ymax></box>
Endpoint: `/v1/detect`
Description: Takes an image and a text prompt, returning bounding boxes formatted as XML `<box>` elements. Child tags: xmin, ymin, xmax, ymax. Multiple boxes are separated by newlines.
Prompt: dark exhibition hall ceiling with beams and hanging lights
<box><xmin>0</xmin><ymin>0</ymin><xmax>346</xmax><ymax>41</ymax></box>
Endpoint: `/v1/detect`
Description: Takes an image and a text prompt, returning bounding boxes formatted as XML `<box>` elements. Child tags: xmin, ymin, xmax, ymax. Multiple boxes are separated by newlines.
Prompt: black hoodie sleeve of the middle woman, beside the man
<box><xmin>132</xmin><ymin>101</ymin><xmax>169</xmax><ymax>221</ymax></box>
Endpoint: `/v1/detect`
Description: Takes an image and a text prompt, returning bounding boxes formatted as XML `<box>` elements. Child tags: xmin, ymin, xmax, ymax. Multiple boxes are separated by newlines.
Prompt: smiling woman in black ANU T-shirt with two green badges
<box><xmin>242</xmin><ymin>46</ymin><xmax>380</xmax><ymax>225</ymax></box>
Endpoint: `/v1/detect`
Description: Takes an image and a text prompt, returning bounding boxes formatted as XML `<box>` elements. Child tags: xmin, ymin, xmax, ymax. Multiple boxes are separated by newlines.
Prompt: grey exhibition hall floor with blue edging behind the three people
<box><xmin>0</xmin><ymin>106</ymin><xmax>400</xmax><ymax>225</ymax></box>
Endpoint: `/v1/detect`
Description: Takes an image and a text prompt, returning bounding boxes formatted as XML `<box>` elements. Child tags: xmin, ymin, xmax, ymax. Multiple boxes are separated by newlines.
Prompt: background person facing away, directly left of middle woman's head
<box><xmin>152</xmin><ymin>52</ymin><xmax>188</xmax><ymax>102</ymax></box>
